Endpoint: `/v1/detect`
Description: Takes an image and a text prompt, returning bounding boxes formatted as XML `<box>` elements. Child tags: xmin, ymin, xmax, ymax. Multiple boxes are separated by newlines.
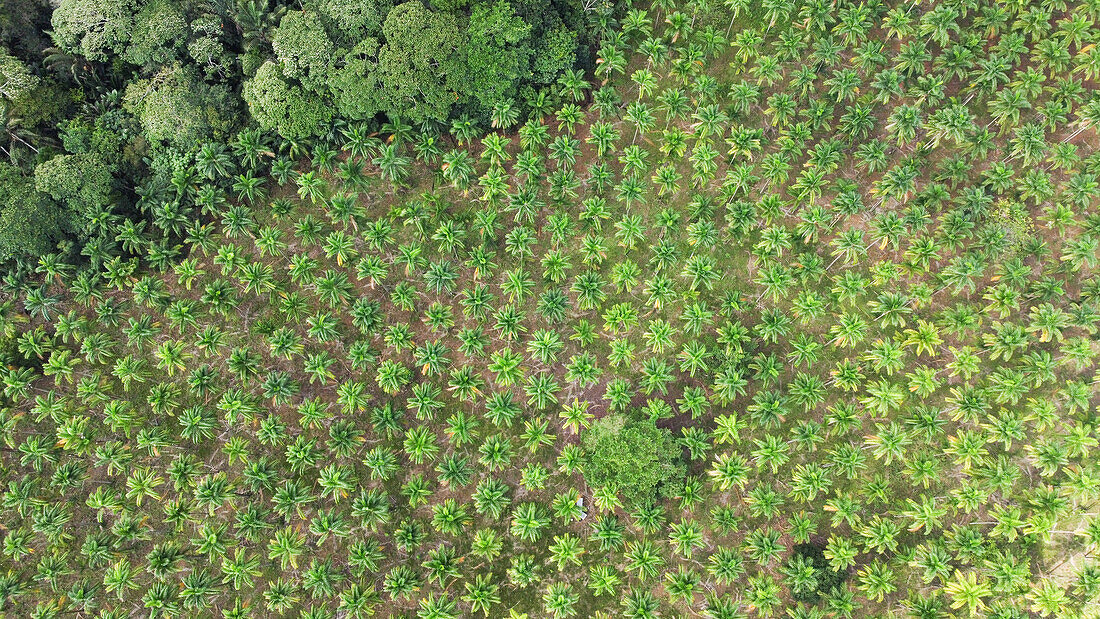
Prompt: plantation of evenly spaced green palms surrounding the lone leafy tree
<box><xmin>0</xmin><ymin>0</ymin><xmax>1100</xmax><ymax>619</ymax></box>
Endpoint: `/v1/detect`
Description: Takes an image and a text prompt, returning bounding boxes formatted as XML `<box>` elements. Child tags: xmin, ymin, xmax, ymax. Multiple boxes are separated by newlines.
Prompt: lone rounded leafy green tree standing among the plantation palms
<box><xmin>581</xmin><ymin>413</ymin><xmax>685</xmax><ymax>506</ymax></box>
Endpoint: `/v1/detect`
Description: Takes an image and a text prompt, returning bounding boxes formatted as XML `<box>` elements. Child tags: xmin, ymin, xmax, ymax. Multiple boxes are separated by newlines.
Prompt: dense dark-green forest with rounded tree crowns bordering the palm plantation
<box><xmin>0</xmin><ymin>0</ymin><xmax>623</xmax><ymax>266</ymax></box>
